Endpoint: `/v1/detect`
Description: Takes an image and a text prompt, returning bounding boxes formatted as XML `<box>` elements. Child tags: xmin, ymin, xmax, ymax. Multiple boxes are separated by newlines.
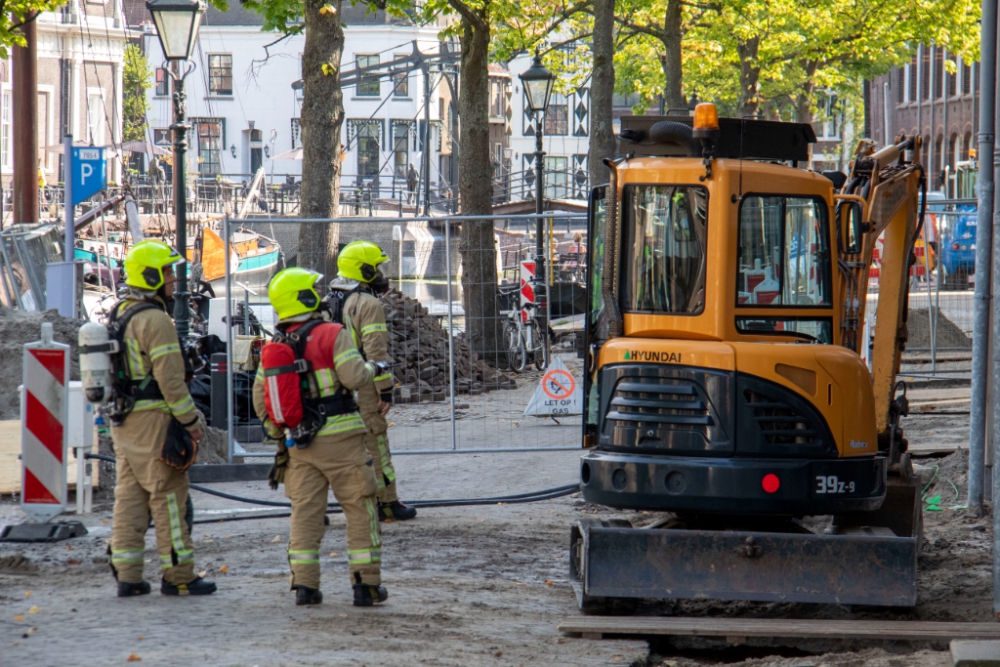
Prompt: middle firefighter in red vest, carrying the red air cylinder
<box><xmin>253</xmin><ymin>267</ymin><xmax>388</xmax><ymax>607</ymax></box>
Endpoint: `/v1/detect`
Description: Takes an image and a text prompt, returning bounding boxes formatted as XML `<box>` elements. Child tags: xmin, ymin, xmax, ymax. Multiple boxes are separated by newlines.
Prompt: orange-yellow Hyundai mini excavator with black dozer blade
<box><xmin>570</xmin><ymin>104</ymin><xmax>926</xmax><ymax>610</ymax></box>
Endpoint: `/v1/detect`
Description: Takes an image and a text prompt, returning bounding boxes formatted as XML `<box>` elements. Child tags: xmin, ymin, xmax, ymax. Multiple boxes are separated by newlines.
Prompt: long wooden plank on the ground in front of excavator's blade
<box><xmin>559</xmin><ymin>616</ymin><xmax>1000</xmax><ymax>641</ymax></box>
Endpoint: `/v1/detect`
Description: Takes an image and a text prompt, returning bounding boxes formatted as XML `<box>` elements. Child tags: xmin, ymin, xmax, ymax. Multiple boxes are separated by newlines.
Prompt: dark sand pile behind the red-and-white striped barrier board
<box><xmin>0</xmin><ymin>307</ymin><xmax>83</xmax><ymax>419</ymax></box>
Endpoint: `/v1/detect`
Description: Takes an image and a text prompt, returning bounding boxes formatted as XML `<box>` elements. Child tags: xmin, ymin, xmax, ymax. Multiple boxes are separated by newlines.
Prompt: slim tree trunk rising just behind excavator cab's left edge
<box><xmin>587</xmin><ymin>0</ymin><xmax>616</xmax><ymax>187</ymax></box>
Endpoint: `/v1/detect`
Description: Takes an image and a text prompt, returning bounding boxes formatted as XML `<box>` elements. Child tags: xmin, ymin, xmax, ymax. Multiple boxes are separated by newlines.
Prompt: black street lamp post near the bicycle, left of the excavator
<box><xmin>521</xmin><ymin>51</ymin><xmax>555</xmax><ymax>357</ymax></box>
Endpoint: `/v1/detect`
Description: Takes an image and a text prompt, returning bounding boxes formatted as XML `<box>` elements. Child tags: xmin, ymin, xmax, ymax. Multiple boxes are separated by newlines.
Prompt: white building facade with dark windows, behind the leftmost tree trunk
<box><xmin>142</xmin><ymin>3</ymin><xmax>447</xmax><ymax>198</ymax></box>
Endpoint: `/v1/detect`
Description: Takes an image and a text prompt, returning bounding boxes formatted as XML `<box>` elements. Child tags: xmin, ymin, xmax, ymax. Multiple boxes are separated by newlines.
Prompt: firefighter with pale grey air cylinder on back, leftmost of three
<box><xmin>111</xmin><ymin>241</ymin><xmax>216</xmax><ymax>597</ymax></box>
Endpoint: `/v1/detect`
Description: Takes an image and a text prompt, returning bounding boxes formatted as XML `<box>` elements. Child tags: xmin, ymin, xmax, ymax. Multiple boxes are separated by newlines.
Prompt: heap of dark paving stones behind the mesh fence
<box><xmin>382</xmin><ymin>290</ymin><xmax>517</xmax><ymax>403</ymax></box>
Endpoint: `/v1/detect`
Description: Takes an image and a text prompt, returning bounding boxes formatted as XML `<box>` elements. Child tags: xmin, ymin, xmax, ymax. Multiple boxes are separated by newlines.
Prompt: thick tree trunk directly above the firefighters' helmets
<box><xmin>297</xmin><ymin>0</ymin><xmax>344</xmax><ymax>279</ymax></box>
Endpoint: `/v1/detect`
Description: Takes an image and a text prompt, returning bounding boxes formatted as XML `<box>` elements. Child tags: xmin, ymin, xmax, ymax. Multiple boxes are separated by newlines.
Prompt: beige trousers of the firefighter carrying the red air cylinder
<box><xmin>285</xmin><ymin>432</ymin><xmax>382</xmax><ymax>588</ymax></box>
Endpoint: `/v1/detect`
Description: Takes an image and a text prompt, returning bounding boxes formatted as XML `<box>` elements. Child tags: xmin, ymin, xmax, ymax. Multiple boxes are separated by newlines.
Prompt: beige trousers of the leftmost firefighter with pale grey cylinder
<box><xmin>111</xmin><ymin>410</ymin><xmax>195</xmax><ymax>584</ymax></box>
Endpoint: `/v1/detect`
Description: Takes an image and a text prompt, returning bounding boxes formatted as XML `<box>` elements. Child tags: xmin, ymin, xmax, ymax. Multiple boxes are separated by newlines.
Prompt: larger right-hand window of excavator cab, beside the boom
<box><xmin>736</xmin><ymin>195</ymin><xmax>832</xmax><ymax>308</ymax></box>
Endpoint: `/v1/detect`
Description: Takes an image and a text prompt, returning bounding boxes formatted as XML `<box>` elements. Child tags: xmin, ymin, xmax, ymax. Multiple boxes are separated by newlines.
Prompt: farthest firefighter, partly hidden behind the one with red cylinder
<box><xmin>330</xmin><ymin>241</ymin><xmax>417</xmax><ymax>521</ymax></box>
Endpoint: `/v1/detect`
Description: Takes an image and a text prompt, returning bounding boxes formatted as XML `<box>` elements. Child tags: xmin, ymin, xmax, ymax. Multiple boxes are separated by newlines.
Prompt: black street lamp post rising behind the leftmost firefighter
<box><xmin>146</xmin><ymin>0</ymin><xmax>205</xmax><ymax>344</ymax></box>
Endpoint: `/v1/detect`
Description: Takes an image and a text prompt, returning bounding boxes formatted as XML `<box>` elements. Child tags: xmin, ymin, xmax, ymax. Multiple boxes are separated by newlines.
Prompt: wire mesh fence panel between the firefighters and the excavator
<box><xmin>219</xmin><ymin>213</ymin><xmax>586</xmax><ymax>460</ymax></box>
